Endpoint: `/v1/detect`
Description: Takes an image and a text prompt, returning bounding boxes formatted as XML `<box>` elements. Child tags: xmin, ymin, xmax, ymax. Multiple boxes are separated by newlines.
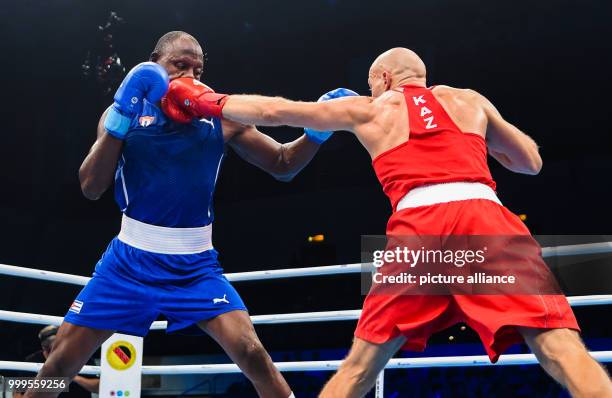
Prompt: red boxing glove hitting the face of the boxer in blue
<box><xmin>162</xmin><ymin>77</ymin><xmax>229</xmax><ymax>123</ymax></box>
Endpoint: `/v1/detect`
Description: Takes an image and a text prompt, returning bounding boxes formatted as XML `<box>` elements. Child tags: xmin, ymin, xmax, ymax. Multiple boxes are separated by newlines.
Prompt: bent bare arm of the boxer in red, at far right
<box><xmin>481</xmin><ymin>96</ymin><xmax>542</xmax><ymax>175</ymax></box>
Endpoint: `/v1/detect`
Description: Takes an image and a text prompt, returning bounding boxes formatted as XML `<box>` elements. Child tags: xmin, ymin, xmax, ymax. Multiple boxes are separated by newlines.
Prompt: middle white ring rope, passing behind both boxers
<box><xmin>0</xmin><ymin>295</ymin><xmax>612</xmax><ymax>330</ymax></box>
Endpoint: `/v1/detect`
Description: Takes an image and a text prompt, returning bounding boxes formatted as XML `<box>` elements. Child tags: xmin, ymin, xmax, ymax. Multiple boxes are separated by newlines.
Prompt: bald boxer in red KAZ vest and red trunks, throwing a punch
<box><xmin>163</xmin><ymin>48</ymin><xmax>612</xmax><ymax>398</ymax></box>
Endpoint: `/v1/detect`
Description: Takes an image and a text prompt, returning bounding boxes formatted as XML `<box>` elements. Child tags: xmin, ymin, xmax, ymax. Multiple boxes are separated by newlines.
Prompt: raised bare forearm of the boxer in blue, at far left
<box><xmin>79</xmin><ymin>107</ymin><xmax>123</xmax><ymax>200</ymax></box>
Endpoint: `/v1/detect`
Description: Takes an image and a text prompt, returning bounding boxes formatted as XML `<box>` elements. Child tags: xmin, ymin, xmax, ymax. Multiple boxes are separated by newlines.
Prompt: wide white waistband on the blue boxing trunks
<box><xmin>117</xmin><ymin>214</ymin><xmax>213</xmax><ymax>254</ymax></box>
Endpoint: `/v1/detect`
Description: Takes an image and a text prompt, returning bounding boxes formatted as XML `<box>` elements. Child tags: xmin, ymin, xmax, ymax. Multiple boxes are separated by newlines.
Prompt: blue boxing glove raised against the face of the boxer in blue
<box><xmin>104</xmin><ymin>62</ymin><xmax>169</xmax><ymax>140</ymax></box>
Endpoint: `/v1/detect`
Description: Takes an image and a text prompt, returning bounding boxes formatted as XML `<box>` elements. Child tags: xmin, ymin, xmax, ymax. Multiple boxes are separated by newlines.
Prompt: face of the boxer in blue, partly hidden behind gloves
<box><xmin>156</xmin><ymin>37</ymin><xmax>204</xmax><ymax>80</ymax></box>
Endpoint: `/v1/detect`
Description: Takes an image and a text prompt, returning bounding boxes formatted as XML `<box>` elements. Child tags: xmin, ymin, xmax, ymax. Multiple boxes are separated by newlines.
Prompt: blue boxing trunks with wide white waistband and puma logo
<box><xmin>64</xmin><ymin>215</ymin><xmax>247</xmax><ymax>336</ymax></box>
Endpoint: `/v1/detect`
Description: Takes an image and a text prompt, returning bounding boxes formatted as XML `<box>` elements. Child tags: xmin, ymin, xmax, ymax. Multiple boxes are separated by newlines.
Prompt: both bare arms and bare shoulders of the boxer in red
<box><xmin>223</xmin><ymin>81</ymin><xmax>542</xmax><ymax>174</ymax></box>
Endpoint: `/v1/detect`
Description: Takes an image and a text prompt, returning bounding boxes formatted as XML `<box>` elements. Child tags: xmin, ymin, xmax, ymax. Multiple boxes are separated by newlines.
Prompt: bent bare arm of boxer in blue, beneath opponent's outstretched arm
<box><xmin>223</xmin><ymin>120</ymin><xmax>319</xmax><ymax>181</ymax></box>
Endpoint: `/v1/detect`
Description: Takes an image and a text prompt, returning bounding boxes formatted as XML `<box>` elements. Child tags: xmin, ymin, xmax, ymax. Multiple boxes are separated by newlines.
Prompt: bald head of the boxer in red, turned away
<box><xmin>368</xmin><ymin>47</ymin><xmax>427</xmax><ymax>97</ymax></box>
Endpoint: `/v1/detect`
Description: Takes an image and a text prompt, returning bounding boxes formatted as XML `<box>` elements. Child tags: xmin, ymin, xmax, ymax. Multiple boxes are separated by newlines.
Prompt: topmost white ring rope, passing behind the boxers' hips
<box><xmin>0</xmin><ymin>242</ymin><xmax>612</xmax><ymax>286</ymax></box>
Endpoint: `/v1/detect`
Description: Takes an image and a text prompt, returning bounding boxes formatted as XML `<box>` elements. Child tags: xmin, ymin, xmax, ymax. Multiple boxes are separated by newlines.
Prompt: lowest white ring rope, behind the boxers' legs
<box><xmin>0</xmin><ymin>351</ymin><xmax>612</xmax><ymax>375</ymax></box>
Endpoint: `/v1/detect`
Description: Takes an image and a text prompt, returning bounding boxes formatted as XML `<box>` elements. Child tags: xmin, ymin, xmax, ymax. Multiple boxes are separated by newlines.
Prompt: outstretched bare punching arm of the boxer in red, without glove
<box><xmin>223</xmin><ymin>95</ymin><xmax>375</xmax><ymax>131</ymax></box>
